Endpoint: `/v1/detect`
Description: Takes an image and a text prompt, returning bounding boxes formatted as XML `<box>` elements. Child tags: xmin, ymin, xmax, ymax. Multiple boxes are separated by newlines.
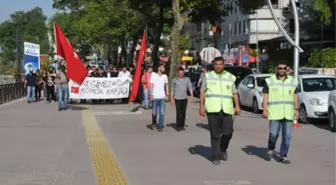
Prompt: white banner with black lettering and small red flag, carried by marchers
<box><xmin>69</xmin><ymin>77</ymin><xmax>130</xmax><ymax>99</ymax></box>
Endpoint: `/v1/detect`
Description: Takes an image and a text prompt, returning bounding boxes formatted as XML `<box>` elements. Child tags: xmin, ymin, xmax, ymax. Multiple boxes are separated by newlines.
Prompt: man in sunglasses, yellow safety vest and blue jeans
<box><xmin>263</xmin><ymin>61</ymin><xmax>299</xmax><ymax>164</ymax></box>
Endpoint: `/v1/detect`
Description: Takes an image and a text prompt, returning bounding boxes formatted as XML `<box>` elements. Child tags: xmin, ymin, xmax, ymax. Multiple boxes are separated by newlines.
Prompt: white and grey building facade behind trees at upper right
<box><xmin>186</xmin><ymin>0</ymin><xmax>290</xmax><ymax>55</ymax></box>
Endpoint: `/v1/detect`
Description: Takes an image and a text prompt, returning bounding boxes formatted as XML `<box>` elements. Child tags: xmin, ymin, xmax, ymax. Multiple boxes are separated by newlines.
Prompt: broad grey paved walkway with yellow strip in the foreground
<box><xmin>0</xmin><ymin>102</ymin><xmax>336</xmax><ymax>185</ymax></box>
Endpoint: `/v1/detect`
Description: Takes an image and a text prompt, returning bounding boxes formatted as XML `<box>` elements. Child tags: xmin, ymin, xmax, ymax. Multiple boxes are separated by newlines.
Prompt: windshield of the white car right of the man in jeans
<box><xmin>302</xmin><ymin>78</ymin><xmax>336</xmax><ymax>92</ymax></box>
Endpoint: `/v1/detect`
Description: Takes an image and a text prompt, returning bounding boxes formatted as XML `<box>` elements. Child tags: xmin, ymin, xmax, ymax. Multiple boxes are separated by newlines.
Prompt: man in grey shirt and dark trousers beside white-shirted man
<box><xmin>170</xmin><ymin>68</ymin><xmax>194</xmax><ymax>131</ymax></box>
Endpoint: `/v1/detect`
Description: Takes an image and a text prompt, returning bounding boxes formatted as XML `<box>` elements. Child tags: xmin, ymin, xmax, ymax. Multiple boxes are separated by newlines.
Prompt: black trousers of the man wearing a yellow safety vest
<box><xmin>207</xmin><ymin>111</ymin><xmax>233</xmax><ymax>158</ymax></box>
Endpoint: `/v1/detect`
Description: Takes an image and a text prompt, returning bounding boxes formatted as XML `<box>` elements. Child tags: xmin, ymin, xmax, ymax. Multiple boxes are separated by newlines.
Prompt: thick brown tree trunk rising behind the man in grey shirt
<box><xmin>169</xmin><ymin>0</ymin><xmax>189</xmax><ymax>84</ymax></box>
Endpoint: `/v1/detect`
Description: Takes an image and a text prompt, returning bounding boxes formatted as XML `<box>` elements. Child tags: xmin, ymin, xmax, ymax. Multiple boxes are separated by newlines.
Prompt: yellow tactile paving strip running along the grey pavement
<box><xmin>82</xmin><ymin>107</ymin><xmax>128</xmax><ymax>185</ymax></box>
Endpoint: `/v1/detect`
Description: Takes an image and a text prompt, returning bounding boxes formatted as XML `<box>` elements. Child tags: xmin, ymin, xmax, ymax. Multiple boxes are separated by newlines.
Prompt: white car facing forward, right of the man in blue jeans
<box><xmin>298</xmin><ymin>74</ymin><xmax>336</xmax><ymax>123</ymax></box>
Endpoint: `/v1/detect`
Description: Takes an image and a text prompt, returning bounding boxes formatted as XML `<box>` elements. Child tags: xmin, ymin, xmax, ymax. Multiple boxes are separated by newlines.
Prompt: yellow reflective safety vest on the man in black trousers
<box><xmin>205</xmin><ymin>71</ymin><xmax>236</xmax><ymax>115</ymax></box>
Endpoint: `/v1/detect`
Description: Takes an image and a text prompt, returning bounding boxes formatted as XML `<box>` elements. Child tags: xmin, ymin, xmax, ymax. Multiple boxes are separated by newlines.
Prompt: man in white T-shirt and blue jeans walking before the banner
<box><xmin>150</xmin><ymin>64</ymin><xmax>169</xmax><ymax>132</ymax></box>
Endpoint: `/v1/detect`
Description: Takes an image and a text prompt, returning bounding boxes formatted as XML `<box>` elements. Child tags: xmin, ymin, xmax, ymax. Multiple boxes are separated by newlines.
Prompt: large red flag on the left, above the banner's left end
<box><xmin>54</xmin><ymin>23</ymin><xmax>88</xmax><ymax>85</ymax></box>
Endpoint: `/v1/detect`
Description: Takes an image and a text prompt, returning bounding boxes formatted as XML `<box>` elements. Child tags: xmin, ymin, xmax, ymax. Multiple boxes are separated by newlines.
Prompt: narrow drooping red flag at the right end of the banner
<box><xmin>129</xmin><ymin>32</ymin><xmax>146</xmax><ymax>102</ymax></box>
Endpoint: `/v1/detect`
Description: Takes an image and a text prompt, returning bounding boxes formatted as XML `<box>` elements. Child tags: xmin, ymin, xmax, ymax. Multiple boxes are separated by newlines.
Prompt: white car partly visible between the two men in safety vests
<box><xmin>237</xmin><ymin>74</ymin><xmax>271</xmax><ymax>113</ymax></box>
